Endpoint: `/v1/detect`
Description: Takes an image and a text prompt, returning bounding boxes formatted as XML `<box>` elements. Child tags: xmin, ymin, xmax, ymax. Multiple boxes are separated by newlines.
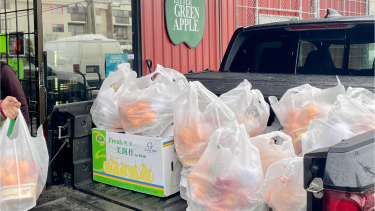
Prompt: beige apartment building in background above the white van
<box><xmin>1</xmin><ymin>0</ymin><xmax>132</xmax><ymax>45</ymax></box>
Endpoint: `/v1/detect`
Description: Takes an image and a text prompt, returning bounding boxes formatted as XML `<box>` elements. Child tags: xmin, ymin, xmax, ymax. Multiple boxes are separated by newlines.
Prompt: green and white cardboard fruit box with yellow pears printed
<box><xmin>92</xmin><ymin>126</ymin><xmax>182</xmax><ymax>197</ymax></box>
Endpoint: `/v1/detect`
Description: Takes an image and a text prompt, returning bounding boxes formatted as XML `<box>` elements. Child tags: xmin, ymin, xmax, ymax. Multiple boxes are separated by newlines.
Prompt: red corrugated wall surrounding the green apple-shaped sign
<box><xmin>141</xmin><ymin>0</ymin><xmax>235</xmax><ymax>75</ymax></box>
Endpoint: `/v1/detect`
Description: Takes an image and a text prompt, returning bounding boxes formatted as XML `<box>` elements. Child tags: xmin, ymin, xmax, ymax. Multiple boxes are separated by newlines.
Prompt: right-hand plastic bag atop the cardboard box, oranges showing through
<box><xmin>118</xmin><ymin>65</ymin><xmax>187</xmax><ymax>136</ymax></box>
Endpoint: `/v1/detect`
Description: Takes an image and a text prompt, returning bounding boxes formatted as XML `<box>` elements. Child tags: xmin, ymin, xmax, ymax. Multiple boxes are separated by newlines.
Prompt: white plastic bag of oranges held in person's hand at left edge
<box><xmin>0</xmin><ymin>111</ymin><xmax>49</xmax><ymax>211</ymax></box>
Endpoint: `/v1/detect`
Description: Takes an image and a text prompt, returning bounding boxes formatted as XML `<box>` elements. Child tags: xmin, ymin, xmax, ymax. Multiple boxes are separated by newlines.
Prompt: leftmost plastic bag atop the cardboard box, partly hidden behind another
<box><xmin>90</xmin><ymin>63</ymin><xmax>137</xmax><ymax>132</ymax></box>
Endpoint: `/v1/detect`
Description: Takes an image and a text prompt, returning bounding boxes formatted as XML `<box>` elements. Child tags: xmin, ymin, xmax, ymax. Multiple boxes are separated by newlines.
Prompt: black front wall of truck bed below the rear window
<box><xmin>185</xmin><ymin>71</ymin><xmax>374</xmax><ymax>98</ymax></box>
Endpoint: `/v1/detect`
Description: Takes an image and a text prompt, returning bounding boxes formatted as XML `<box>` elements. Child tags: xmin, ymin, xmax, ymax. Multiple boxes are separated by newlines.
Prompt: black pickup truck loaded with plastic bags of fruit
<box><xmin>34</xmin><ymin>11</ymin><xmax>375</xmax><ymax>211</ymax></box>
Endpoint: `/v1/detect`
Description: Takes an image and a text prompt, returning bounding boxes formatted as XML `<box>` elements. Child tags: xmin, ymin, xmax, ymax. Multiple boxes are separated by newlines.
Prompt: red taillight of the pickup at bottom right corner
<box><xmin>323</xmin><ymin>188</ymin><xmax>375</xmax><ymax>211</ymax></box>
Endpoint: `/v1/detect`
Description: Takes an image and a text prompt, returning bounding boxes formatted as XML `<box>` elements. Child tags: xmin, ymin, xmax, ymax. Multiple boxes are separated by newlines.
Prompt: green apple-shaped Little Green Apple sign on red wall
<box><xmin>165</xmin><ymin>0</ymin><xmax>206</xmax><ymax>48</ymax></box>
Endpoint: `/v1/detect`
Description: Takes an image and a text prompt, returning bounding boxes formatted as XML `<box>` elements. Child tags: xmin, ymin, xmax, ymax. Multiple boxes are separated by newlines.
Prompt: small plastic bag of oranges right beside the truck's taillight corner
<box><xmin>260</xmin><ymin>157</ymin><xmax>307</xmax><ymax>211</ymax></box>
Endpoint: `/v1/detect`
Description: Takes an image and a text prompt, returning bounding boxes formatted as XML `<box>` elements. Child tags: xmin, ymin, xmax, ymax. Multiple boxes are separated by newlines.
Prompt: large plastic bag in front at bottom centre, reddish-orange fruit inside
<box><xmin>186</xmin><ymin>124</ymin><xmax>266</xmax><ymax>211</ymax></box>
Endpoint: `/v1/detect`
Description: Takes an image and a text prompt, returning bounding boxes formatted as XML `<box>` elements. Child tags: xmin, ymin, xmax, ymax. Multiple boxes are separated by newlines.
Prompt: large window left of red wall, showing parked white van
<box><xmin>42</xmin><ymin>0</ymin><xmax>132</xmax><ymax>113</ymax></box>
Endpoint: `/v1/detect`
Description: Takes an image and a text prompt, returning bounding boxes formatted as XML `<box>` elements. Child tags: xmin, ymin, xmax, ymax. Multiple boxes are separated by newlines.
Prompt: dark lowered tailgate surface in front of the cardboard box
<box><xmin>32</xmin><ymin>182</ymin><xmax>187</xmax><ymax>211</ymax></box>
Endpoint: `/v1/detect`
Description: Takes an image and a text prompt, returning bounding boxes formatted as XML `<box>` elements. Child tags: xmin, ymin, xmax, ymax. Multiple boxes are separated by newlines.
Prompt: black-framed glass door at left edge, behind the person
<box><xmin>0</xmin><ymin>0</ymin><xmax>45</xmax><ymax>136</ymax></box>
